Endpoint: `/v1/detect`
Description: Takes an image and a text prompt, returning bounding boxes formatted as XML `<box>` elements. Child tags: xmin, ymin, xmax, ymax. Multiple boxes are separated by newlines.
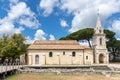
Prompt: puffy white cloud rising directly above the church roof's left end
<box><xmin>34</xmin><ymin>29</ymin><xmax>46</xmax><ymax>40</ymax></box>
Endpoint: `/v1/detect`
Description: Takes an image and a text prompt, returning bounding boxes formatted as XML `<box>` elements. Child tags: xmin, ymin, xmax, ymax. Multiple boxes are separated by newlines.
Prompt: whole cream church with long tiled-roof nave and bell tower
<box><xmin>27</xmin><ymin>16</ymin><xmax>109</xmax><ymax>66</ymax></box>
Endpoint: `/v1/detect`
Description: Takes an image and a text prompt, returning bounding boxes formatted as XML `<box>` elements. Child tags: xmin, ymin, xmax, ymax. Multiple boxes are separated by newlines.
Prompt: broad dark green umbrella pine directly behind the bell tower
<box><xmin>60</xmin><ymin>28</ymin><xmax>115</xmax><ymax>47</ymax></box>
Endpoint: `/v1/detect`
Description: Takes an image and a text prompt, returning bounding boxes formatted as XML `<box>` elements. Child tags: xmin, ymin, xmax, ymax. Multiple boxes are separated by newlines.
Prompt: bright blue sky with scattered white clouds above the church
<box><xmin>0</xmin><ymin>0</ymin><xmax>120</xmax><ymax>43</ymax></box>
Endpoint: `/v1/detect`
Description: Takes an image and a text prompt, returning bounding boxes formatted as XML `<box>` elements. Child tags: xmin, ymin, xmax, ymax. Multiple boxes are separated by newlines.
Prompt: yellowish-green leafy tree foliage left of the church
<box><xmin>0</xmin><ymin>34</ymin><xmax>28</xmax><ymax>59</ymax></box>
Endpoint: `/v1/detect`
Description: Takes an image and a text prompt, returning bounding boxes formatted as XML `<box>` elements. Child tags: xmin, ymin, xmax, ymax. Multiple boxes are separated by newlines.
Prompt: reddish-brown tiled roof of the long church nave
<box><xmin>28</xmin><ymin>40</ymin><xmax>88</xmax><ymax>50</ymax></box>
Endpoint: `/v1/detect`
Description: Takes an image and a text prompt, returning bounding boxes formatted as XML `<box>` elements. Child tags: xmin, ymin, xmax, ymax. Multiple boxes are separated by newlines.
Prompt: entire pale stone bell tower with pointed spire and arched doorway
<box><xmin>93</xmin><ymin>14</ymin><xmax>109</xmax><ymax>64</ymax></box>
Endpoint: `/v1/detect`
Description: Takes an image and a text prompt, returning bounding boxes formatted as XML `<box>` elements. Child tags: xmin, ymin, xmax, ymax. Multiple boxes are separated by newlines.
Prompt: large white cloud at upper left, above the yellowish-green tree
<box><xmin>0</xmin><ymin>0</ymin><xmax>40</xmax><ymax>35</ymax></box>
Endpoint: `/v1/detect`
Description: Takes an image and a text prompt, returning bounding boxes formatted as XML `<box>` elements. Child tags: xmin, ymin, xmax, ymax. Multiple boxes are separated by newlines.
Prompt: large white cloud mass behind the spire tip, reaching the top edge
<box><xmin>40</xmin><ymin>0</ymin><xmax>120</xmax><ymax>32</ymax></box>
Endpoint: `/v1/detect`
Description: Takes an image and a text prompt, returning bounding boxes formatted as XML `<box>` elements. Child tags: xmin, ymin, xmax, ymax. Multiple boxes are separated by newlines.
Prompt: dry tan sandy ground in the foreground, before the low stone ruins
<box><xmin>6</xmin><ymin>74</ymin><xmax>120</xmax><ymax>80</ymax></box>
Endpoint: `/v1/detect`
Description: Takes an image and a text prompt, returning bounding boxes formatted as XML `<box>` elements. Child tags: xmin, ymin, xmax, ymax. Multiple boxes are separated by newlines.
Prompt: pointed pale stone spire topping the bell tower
<box><xmin>94</xmin><ymin>13</ymin><xmax>104</xmax><ymax>34</ymax></box>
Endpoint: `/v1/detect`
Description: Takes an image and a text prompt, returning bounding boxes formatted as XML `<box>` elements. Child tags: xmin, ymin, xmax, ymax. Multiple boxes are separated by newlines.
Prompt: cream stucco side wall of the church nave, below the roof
<box><xmin>28</xmin><ymin>50</ymin><xmax>93</xmax><ymax>65</ymax></box>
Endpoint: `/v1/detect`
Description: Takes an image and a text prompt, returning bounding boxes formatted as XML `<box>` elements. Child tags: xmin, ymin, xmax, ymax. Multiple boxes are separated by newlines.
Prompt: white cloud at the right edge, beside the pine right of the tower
<box><xmin>108</xmin><ymin>20</ymin><xmax>120</xmax><ymax>38</ymax></box>
